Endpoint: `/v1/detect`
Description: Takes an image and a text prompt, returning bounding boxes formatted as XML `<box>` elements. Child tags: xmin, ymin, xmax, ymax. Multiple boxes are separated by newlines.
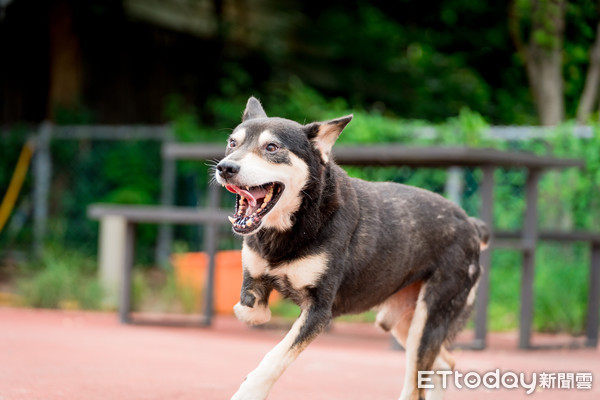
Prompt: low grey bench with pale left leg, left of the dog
<box><xmin>88</xmin><ymin>203</ymin><xmax>231</xmax><ymax>325</ymax></box>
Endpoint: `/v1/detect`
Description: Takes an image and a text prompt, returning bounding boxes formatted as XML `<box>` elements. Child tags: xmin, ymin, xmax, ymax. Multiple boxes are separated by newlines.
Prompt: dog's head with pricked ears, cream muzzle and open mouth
<box><xmin>215</xmin><ymin>97</ymin><xmax>352</xmax><ymax>235</ymax></box>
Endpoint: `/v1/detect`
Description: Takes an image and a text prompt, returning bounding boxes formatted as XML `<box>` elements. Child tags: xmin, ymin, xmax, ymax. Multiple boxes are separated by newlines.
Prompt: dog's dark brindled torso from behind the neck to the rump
<box><xmin>318</xmin><ymin>162</ymin><xmax>480</xmax><ymax>315</ymax></box>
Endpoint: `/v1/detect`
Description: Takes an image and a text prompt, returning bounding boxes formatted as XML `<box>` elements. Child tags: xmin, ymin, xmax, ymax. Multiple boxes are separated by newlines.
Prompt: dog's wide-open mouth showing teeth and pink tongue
<box><xmin>225</xmin><ymin>182</ymin><xmax>284</xmax><ymax>234</ymax></box>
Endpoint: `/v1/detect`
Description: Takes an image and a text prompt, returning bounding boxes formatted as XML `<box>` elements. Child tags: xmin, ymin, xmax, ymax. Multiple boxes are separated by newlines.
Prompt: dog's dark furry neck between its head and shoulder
<box><xmin>244</xmin><ymin>161</ymin><xmax>347</xmax><ymax>265</ymax></box>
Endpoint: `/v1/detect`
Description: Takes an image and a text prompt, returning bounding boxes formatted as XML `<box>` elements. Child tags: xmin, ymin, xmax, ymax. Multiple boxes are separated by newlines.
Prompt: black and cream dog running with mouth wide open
<box><xmin>215</xmin><ymin>97</ymin><xmax>489</xmax><ymax>400</ymax></box>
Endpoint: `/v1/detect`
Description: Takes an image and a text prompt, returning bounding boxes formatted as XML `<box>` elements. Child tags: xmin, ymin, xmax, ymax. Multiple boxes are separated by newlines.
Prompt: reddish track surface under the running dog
<box><xmin>0</xmin><ymin>308</ymin><xmax>600</xmax><ymax>400</ymax></box>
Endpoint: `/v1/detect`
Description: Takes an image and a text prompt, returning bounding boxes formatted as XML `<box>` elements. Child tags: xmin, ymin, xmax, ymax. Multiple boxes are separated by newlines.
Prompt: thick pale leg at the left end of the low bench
<box><xmin>98</xmin><ymin>215</ymin><xmax>127</xmax><ymax>308</ymax></box>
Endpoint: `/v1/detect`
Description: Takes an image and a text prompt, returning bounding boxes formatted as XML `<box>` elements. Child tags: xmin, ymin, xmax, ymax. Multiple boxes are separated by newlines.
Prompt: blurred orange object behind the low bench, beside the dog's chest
<box><xmin>172</xmin><ymin>250</ymin><xmax>280</xmax><ymax>314</ymax></box>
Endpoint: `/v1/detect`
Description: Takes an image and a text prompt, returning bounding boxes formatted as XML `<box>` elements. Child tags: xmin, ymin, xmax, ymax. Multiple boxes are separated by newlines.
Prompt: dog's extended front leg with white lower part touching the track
<box><xmin>232</xmin><ymin>306</ymin><xmax>331</xmax><ymax>400</ymax></box>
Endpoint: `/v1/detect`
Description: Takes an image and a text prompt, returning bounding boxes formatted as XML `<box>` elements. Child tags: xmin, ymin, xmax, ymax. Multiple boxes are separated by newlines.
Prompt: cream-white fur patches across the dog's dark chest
<box><xmin>242</xmin><ymin>243</ymin><xmax>328</xmax><ymax>290</ymax></box>
